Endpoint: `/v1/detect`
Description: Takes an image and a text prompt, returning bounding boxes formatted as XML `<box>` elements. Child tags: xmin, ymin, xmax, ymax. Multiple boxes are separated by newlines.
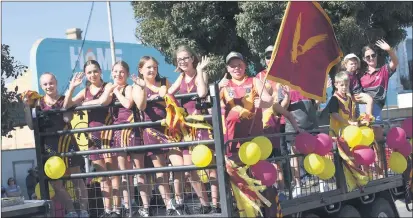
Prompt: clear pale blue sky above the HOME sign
<box><xmin>1</xmin><ymin>2</ymin><xmax>138</xmax><ymax>66</ymax></box>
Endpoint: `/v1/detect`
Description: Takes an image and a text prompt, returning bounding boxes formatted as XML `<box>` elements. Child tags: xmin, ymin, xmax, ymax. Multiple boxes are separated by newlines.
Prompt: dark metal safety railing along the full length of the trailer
<box><xmin>32</xmin><ymin>81</ymin><xmax>405</xmax><ymax>217</ymax></box>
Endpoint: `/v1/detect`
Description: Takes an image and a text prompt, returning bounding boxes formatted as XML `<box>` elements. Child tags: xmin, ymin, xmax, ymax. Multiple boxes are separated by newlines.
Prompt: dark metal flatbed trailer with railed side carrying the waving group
<box><xmin>26</xmin><ymin>84</ymin><xmax>412</xmax><ymax>217</ymax></box>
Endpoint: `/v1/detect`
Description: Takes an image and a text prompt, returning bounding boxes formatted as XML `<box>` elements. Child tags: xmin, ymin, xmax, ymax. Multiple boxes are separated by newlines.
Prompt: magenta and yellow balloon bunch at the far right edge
<box><xmin>386</xmin><ymin>118</ymin><xmax>413</xmax><ymax>173</ymax></box>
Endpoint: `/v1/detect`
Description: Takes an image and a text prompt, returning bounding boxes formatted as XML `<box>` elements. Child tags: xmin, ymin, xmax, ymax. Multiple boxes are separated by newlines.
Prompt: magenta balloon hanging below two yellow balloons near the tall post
<box><xmin>250</xmin><ymin>160</ymin><xmax>277</xmax><ymax>187</ymax></box>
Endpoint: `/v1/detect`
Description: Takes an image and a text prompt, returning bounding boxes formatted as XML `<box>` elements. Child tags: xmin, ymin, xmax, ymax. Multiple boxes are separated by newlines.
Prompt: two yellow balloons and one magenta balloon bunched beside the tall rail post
<box><xmin>238</xmin><ymin>136</ymin><xmax>277</xmax><ymax>186</ymax></box>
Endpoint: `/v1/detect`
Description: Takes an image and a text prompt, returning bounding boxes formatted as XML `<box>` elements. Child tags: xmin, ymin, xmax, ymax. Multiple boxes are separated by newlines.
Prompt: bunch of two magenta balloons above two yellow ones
<box><xmin>295</xmin><ymin>132</ymin><xmax>336</xmax><ymax>180</ymax></box>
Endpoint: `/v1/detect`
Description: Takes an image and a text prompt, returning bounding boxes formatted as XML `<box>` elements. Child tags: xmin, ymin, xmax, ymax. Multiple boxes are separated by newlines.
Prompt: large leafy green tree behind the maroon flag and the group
<box><xmin>132</xmin><ymin>1</ymin><xmax>413</xmax><ymax>80</ymax></box>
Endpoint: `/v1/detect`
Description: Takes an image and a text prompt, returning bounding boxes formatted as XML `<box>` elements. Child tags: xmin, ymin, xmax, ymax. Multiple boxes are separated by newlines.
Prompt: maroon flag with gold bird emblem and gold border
<box><xmin>267</xmin><ymin>2</ymin><xmax>343</xmax><ymax>102</ymax></box>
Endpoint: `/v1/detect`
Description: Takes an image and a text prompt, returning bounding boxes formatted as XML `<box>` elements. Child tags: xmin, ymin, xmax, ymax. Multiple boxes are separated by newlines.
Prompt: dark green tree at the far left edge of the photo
<box><xmin>1</xmin><ymin>44</ymin><xmax>27</xmax><ymax>137</ymax></box>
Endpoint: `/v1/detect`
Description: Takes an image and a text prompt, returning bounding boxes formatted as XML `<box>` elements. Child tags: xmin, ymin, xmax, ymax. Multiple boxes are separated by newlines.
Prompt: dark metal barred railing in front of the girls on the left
<box><xmin>32</xmin><ymin>84</ymin><xmax>232</xmax><ymax>217</ymax></box>
